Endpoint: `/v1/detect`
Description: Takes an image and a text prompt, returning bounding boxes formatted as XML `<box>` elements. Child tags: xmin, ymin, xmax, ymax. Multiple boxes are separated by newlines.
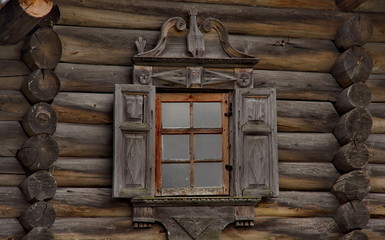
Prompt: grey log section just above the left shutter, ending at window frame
<box><xmin>54</xmin><ymin>63</ymin><xmax>132</xmax><ymax>93</ymax></box>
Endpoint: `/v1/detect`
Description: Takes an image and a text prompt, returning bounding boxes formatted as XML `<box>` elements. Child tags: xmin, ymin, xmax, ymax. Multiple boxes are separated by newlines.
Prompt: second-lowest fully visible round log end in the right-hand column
<box><xmin>332</xmin><ymin>170</ymin><xmax>370</xmax><ymax>203</ymax></box>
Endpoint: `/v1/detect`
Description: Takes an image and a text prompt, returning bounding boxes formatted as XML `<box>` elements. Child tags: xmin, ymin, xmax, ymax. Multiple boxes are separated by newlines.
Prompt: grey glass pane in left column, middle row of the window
<box><xmin>162</xmin><ymin>135</ymin><xmax>190</xmax><ymax>160</ymax></box>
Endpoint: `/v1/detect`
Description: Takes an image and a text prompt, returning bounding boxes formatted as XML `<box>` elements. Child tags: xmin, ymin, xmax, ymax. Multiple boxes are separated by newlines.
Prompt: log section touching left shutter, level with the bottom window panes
<box><xmin>51</xmin><ymin>158</ymin><xmax>112</xmax><ymax>187</ymax></box>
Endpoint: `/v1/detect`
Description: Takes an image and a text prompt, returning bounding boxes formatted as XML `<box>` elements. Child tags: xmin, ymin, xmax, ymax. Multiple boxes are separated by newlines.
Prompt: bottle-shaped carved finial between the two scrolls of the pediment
<box><xmin>187</xmin><ymin>8</ymin><xmax>205</xmax><ymax>57</ymax></box>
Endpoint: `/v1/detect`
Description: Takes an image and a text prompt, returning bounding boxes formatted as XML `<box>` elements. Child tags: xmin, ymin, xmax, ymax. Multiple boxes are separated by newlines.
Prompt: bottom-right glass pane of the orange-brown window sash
<box><xmin>194</xmin><ymin>163</ymin><xmax>223</xmax><ymax>187</ymax></box>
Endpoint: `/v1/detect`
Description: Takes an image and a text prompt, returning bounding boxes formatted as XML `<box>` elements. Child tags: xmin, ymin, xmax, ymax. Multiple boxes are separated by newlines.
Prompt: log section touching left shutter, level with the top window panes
<box><xmin>51</xmin><ymin>93</ymin><xmax>113</xmax><ymax>124</ymax></box>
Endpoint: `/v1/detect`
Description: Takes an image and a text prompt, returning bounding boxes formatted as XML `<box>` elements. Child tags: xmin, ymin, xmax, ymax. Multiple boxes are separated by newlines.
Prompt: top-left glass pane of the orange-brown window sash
<box><xmin>162</xmin><ymin>103</ymin><xmax>190</xmax><ymax>128</ymax></box>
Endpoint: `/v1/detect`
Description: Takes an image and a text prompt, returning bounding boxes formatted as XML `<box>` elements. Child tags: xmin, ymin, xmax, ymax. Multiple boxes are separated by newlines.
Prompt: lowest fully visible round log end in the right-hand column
<box><xmin>334</xmin><ymin>200</ymin><xmax>370</xmax><ymax>232</ymax></box>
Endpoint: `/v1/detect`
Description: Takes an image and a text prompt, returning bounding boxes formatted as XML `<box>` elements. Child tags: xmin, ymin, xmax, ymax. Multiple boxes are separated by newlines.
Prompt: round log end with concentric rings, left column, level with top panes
<box><xmin>21</xmin><ymin>103</ymin><xmax>57</xmax><ymax>137</ymax></box>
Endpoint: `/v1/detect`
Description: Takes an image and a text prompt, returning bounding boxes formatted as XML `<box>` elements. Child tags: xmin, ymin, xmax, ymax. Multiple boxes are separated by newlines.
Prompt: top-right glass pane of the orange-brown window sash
<box><xmin>193</xmin><ymin>102</ymin><xmax>222</xmax><ymax>128</ymax></box>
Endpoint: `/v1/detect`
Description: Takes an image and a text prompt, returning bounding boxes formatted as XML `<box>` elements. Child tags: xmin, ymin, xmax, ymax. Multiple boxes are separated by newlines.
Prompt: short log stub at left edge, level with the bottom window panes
<box><xmin>0</xmin><ymin>157</ymin><xmax>26</xmax><ymax>186</ymax></box>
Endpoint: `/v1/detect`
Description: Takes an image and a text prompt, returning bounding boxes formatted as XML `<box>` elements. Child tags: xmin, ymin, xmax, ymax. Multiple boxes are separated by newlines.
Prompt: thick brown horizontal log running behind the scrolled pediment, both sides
<box><xmin>54</xmin><ymin>26</ymin><xmax>340</xmax><ymax>72</ymax></box>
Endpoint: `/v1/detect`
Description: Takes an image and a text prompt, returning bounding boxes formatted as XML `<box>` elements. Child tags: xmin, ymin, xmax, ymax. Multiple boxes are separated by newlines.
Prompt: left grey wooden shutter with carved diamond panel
<box><xmin>113</xmin><ymin>84</ymin><xmax>155</xmax><ymax>198</ymax></box>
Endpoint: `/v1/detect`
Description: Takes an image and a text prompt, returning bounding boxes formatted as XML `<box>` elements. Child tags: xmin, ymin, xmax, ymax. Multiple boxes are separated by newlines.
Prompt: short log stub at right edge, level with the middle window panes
<box><xmin>365</xmin><ymin>134</ymin><xmax>385</xmax><ymax>163</ymax></box>
